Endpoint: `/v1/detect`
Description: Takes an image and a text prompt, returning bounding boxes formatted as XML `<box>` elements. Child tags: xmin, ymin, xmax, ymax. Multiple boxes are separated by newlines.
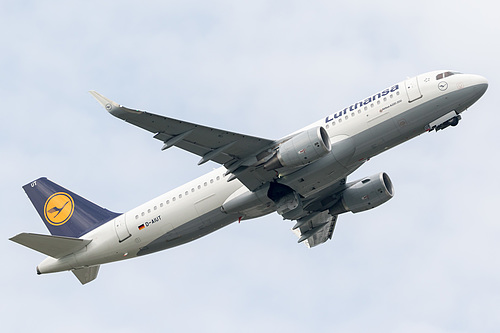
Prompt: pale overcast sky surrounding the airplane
<box><xmin>0</xmin><ymin>0</ymin><xmax>500</xmax><ymax>333</ymax></box>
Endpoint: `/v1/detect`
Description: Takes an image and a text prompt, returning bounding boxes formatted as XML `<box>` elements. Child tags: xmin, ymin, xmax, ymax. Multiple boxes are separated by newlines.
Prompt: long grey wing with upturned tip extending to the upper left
<box><xmin>90</xmin><ymin>91</ymin><xmax>276</xmax><ymax>190</ymax></box>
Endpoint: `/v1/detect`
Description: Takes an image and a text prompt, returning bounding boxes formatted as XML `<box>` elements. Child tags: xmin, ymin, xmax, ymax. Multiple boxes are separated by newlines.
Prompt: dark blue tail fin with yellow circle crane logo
<box><xmin>23</xmin><ymin>178</ymin><xmax>120</xmax><ymax>238</ymax></box>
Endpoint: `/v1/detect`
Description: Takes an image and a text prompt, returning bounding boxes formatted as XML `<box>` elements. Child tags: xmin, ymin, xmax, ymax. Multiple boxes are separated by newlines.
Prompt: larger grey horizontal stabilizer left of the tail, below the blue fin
<box><xmin>10</xmin><ymin>232</ymin><xmax>92</xmax><ymax>259</ymax></box>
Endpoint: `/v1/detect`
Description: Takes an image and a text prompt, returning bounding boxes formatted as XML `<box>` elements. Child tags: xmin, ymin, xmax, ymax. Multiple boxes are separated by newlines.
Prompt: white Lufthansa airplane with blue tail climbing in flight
<box><xmin>10</xmin><ymin>70</ymin><xmax>488</xmax><ymax>284</ymax></box>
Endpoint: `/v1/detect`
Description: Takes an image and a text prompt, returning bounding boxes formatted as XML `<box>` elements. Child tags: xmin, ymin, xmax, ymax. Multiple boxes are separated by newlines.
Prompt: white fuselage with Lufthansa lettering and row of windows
<box><xmin>38</xmin><ymin>71</ymin><xmax>486</xmax><ymax>273</ymax></box>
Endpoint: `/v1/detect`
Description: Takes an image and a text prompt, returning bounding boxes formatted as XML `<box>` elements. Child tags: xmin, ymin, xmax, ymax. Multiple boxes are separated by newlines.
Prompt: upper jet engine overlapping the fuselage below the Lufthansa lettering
<box><xmin>264</xmin><ymin>126</ymin><xmax>332</xmax><ymax>170</ymax></box>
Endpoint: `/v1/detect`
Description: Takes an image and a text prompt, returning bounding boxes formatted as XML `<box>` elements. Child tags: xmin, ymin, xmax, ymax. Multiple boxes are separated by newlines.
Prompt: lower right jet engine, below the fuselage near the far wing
<box><xmin>330</xmin><ymin>172</ymin><xmax>394</xmax><ymax>215</ymax></box>
